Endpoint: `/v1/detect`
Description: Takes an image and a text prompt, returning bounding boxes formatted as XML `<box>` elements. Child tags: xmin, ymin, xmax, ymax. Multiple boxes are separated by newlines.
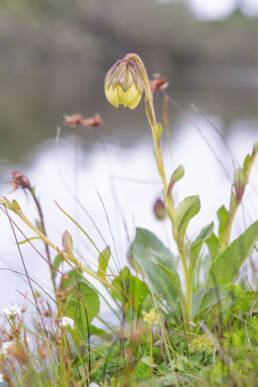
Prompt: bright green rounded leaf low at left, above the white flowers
<box><xmin>60</xmin><ymin>270</ymin><xmax>100</xmax><ymax>337</ymax></box>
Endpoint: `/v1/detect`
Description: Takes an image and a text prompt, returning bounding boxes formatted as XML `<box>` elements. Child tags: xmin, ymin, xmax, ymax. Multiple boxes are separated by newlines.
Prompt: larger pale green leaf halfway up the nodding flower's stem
<box><xmin>174</xmin><ymin>196</ymin><xmax>201</xmax><ymax>243</ymax></box>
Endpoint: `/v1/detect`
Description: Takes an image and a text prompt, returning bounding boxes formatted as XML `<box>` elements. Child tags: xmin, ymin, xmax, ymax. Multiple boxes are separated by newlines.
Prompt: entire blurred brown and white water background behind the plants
<box><xmin>0</xmin><ymin>0</ymin><xmax>258</xmax><ymax>307</ymax></box>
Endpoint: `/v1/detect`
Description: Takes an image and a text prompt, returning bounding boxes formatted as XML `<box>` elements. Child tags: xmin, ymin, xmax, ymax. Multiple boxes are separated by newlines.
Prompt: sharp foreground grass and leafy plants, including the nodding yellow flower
<box><xmin>0</xmin><ymin>54</ymin><xmax>258</xmax><ymax>387</ymax></box>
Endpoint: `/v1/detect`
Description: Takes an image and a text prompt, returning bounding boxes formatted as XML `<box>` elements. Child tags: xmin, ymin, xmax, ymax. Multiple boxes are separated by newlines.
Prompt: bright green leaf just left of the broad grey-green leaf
<box><xmin>111</xmin><ymin>266</ymin><xmax>149</xmax><ymax>312</ymax></box>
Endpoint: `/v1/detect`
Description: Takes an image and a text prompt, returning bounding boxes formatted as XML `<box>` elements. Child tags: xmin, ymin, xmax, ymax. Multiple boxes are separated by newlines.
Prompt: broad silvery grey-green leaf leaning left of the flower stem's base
<box><xmin>132</xmin><ymin>228</ymin><xmax>183</xmax><ymax>310</ymax></box>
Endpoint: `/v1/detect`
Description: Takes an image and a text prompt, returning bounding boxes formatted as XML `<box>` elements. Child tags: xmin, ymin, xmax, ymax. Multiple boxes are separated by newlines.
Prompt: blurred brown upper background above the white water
<box><xmin>0</xmin><ymin>0</ymin><xmax>258</xmax><ymax>164</ymax></box>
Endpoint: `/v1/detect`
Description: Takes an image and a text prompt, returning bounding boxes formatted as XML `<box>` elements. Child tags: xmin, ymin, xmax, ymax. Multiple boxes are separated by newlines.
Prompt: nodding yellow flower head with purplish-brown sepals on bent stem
<box><xmin>105</xmin><ymin>59</ymin><xmax>144</xmax><ymax>109</ymax></box>
